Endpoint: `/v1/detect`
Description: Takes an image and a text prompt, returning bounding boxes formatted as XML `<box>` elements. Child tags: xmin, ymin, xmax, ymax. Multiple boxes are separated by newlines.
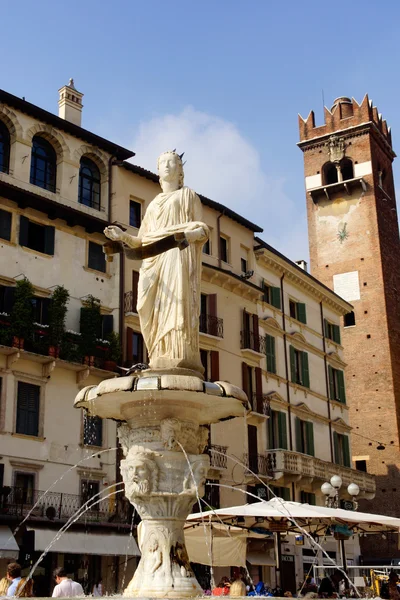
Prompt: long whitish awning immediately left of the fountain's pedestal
<box><xmin>30</xmin><ymin>527</ymin><xmax>140</xmax><ymax>556</ymax></box>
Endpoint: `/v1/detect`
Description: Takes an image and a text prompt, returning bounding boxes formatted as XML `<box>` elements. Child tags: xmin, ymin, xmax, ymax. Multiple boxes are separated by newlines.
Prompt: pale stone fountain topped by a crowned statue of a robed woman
<box><xmin>75</xmin><ymin>152</ymin><xmax>248</xmax><ymax>598</ymax></box>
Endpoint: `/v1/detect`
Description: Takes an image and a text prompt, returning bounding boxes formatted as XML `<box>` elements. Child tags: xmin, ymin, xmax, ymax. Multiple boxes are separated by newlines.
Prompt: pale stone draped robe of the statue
<box><xmin>137</xmin><ymin>187</ymin><xmax>208</xmax><ymax>370</ymax></box>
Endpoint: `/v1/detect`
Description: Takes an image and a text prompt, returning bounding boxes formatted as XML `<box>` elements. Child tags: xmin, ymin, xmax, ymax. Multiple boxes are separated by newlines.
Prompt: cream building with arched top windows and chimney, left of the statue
<box><xmin>0</xmin><ymin>83</ymin><xmax>136</xmax><ymax>596</ymax></box>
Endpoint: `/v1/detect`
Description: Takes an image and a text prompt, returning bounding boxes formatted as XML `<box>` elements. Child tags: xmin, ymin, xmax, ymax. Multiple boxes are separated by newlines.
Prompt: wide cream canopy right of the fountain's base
<box><xmin>187</xmin><ymin>498</ymin><xmax>400</xmax><ymax>534</ymax></box>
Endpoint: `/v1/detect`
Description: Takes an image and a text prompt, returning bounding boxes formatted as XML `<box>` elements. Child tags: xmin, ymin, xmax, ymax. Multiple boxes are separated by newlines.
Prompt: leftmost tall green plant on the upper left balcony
<box><xmin>10</xmin><ymin>277</ymin><xmax>33</xmax><ymax>349</ymax></box>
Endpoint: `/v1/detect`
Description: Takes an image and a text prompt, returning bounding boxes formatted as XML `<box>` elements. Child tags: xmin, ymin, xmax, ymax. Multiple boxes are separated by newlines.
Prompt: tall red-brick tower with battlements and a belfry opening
<box><xmin>299</xmin><ymin>96</ymin><xmax>400</xmax><ymax>564</ymax></box>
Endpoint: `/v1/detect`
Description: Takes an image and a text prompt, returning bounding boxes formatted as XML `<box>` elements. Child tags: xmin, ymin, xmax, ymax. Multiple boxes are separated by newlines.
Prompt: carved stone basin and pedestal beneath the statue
<box><xmin>75</xmin><ymin>371</ymin><xmax>248</xmax><ymax>598</ymax></box>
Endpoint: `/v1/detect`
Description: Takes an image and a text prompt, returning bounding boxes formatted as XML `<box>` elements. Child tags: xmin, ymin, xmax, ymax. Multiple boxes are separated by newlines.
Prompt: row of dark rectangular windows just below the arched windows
<box><xmin>0</xmin><ymin>209</ymin><xmax>106</xmax><ymax>273</ymax></box>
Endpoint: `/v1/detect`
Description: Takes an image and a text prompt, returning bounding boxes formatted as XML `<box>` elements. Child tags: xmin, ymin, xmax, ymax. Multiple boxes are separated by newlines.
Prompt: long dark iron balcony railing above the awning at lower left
<box><xmin>0</xmin><ymin>486</ymin><xmax>127</xmax><ymax>523</ymax></box>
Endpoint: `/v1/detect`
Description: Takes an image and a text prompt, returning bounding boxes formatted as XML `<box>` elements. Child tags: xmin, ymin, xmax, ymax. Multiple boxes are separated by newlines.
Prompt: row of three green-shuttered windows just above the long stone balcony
<box><xmin>267</xmin><ymin>410</ymin><xmax>351</xmax><ymax>467</ymax></box>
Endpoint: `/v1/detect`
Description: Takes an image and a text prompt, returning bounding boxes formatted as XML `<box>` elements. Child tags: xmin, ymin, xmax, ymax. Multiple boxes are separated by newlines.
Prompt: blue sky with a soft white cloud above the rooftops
<box><xmin>0</xmin><ymin>0</ymin><xmax>400</xmax><ymax>259</ymax></box>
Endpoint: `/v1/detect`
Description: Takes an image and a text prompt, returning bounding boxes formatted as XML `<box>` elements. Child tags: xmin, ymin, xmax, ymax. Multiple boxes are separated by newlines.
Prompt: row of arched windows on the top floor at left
<box><xmin>0</xmin><ymin>121</ymin><xmax>100</xmax><ymax>210</ymax></box>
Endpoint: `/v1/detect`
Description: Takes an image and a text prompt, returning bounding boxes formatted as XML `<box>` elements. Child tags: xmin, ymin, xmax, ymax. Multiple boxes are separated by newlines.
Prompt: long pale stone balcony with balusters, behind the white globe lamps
<box><xmin>267</xmin><ymin>450</ymin><xmax>376</xmax><ymax>498</ymax></box>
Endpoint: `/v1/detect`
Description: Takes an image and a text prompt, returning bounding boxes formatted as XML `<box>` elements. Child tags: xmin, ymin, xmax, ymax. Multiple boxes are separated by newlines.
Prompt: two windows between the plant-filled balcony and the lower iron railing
<box><xmin>15</xmin><ymin>381</ymin><xmax>103</xmax><ymax>447</ymax></box>
